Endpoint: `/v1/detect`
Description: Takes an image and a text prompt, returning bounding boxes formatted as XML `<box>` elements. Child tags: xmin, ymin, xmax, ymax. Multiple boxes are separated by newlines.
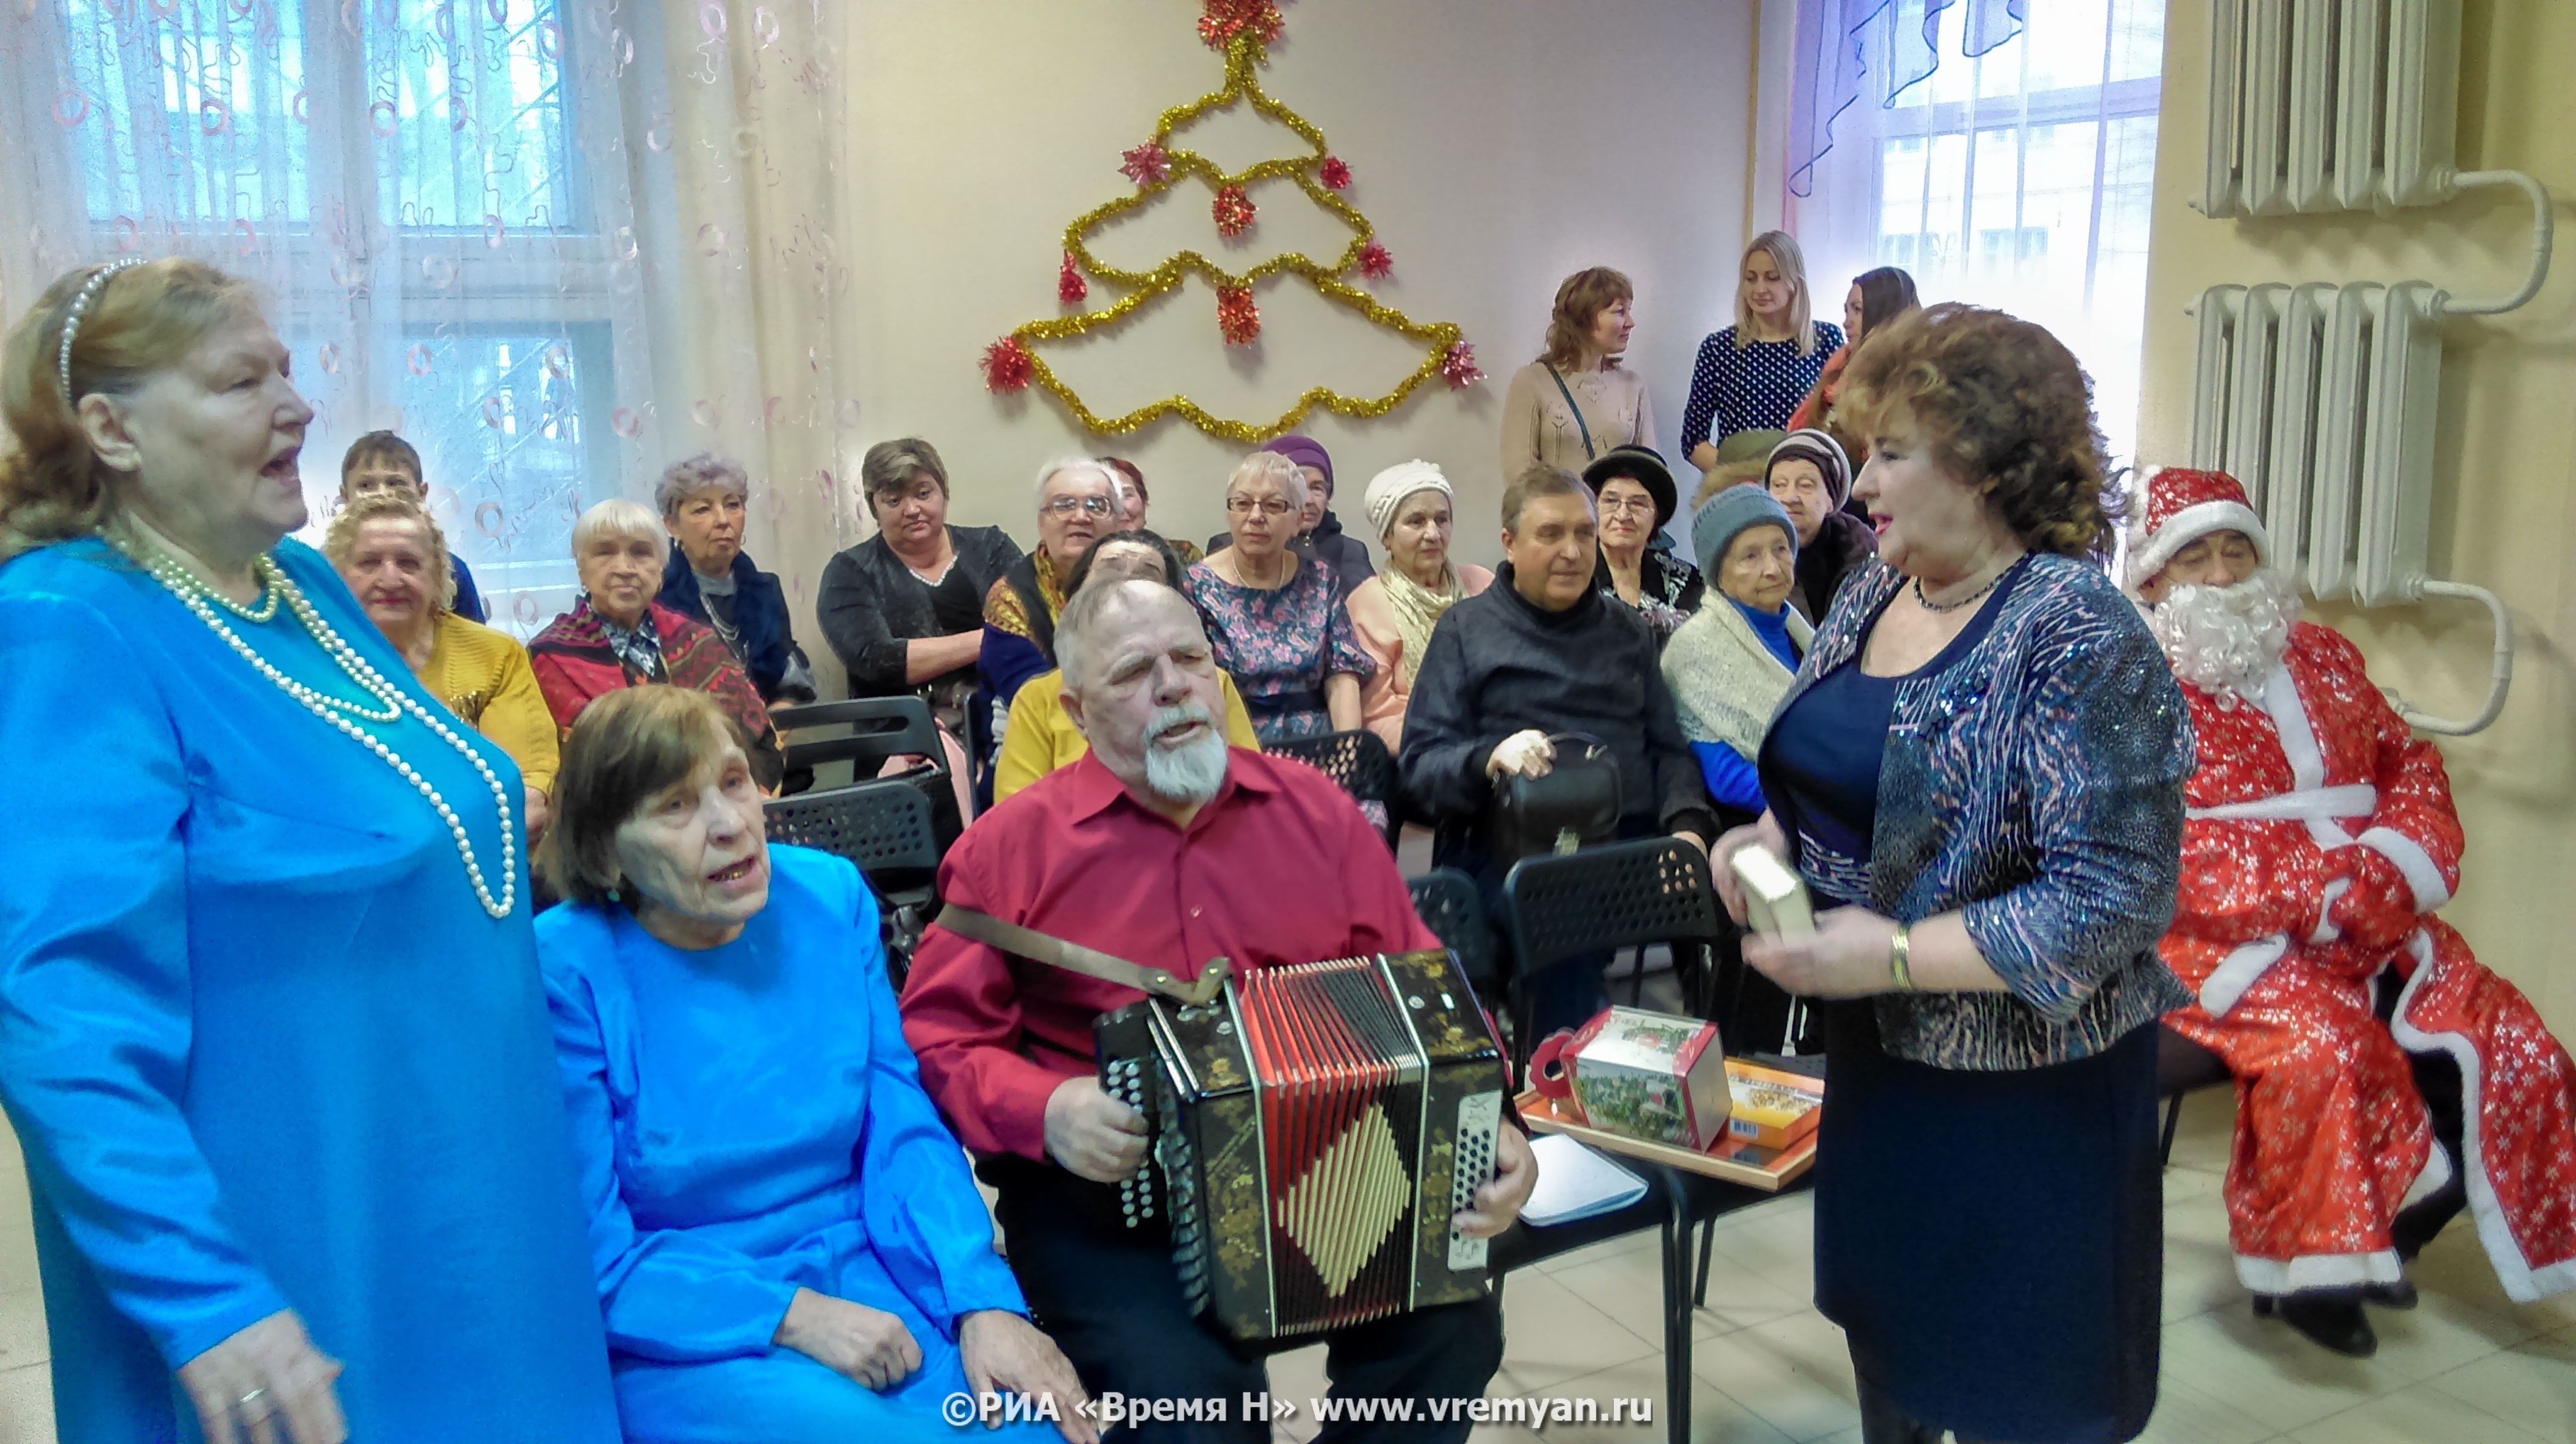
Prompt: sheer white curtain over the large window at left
<box><xmin>0</xmin><ymin>0</ymin><xmax>855</xmax><ymax>636</ymax></box>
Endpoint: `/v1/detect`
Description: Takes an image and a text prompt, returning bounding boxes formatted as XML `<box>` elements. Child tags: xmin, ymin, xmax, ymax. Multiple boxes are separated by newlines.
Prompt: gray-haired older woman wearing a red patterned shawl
<box><xmin>528</xmin><ymin>497</ymin><xmax>785</xmax><ymax>790</ymax></box>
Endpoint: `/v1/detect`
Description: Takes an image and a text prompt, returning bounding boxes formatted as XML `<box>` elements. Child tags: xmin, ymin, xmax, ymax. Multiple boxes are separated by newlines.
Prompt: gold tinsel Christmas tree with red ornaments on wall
<box><xmin>984</xmin><ymin>0</ymin><xmax>1484</xmax><ymax>443</ymax></box>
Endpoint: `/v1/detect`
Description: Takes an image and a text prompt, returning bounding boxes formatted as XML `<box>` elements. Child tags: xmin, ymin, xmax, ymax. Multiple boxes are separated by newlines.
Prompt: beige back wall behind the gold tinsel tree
<box><xmin>755</xmin><ymin>0</ymin><xmax>1780</xmax><ymax>620</ymax></box>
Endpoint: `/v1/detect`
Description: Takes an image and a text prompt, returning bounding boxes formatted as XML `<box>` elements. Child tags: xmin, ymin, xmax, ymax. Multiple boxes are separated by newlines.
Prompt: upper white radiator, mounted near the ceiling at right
<box><xmin>2192</xmin><ymin>0</ymin><xmax>2460</xmax><ymax>216</ymax></box>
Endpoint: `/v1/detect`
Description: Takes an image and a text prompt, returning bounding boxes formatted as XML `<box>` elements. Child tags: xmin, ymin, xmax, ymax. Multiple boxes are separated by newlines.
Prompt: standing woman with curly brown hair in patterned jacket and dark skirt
<box><xmin>1713</xmin><ymin>306</ymin><xmax>2192</xmax><ymax>1444</ymax></box>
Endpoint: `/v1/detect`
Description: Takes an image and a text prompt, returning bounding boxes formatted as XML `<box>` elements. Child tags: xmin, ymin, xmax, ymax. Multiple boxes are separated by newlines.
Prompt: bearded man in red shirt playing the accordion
<box><xmin>904</xmin><ymin>582</ymin><xmax>1538</xmax><ymax>1439</ymax></box>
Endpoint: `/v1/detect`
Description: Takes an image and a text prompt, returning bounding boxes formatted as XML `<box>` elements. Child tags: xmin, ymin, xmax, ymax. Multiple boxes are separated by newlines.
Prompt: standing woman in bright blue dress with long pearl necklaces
<box><xmin>0</xmin><ymin>260</ymin><xmax>618</xmax><ymax>1444</ymax></box>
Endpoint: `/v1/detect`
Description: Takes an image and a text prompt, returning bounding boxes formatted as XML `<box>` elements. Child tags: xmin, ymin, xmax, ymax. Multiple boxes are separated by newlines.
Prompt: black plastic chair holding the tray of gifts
<box><xmin>1497</xmin><ymin>837</ymin><xmax>1775</xmax><ymax>1444</ymax></box>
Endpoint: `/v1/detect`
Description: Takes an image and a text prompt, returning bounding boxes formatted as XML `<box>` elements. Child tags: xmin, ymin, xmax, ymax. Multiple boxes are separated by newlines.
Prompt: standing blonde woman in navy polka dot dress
<box><xmin>1682</xmin><ymin>232</ymin><xmax>1842</xmax><ymax>471</ymax></box>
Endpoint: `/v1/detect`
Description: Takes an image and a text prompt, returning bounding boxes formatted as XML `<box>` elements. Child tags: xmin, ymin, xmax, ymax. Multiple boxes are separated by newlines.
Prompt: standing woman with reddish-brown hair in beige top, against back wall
<box><xmin>1502</xmin><ymin>265</ymin><xmax>1654</xmax><ymax>476</ymax></box>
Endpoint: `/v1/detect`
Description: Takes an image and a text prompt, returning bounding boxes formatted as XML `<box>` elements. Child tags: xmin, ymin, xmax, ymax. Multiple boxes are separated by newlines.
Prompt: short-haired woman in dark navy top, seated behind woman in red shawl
<box><xmin>652</xmin><ymin>453</ymin><xmax>817</xmax><ymax>706</ymax></box>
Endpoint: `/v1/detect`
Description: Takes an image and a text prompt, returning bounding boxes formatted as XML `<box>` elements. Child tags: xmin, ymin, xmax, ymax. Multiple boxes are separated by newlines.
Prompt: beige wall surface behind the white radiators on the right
<box><xmin>2138</xmin><ymin>0</ymin><xmax>2576</xmax><ymax>1035</ymax></box>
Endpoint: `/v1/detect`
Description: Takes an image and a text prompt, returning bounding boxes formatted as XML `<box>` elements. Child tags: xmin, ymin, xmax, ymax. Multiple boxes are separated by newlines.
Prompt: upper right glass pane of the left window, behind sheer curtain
<box><xmin>366</xmin><ymin>0</ymin><xmax>585</xmax><ymax>230</ymax></box>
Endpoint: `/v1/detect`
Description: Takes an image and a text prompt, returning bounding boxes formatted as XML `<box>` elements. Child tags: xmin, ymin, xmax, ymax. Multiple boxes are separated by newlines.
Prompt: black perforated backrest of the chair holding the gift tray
<box><xmin>1502</xmin><ymin>837</ymin><xmax>1726</xmax><ymax>973</ymax></box>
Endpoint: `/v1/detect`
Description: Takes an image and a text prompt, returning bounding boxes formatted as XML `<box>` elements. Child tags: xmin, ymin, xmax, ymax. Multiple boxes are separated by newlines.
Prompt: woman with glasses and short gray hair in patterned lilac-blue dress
<box><xmin>1182</xmin><ymin>451</ymin><xmax>1378</xmax><ymax>746</ymax></box>
